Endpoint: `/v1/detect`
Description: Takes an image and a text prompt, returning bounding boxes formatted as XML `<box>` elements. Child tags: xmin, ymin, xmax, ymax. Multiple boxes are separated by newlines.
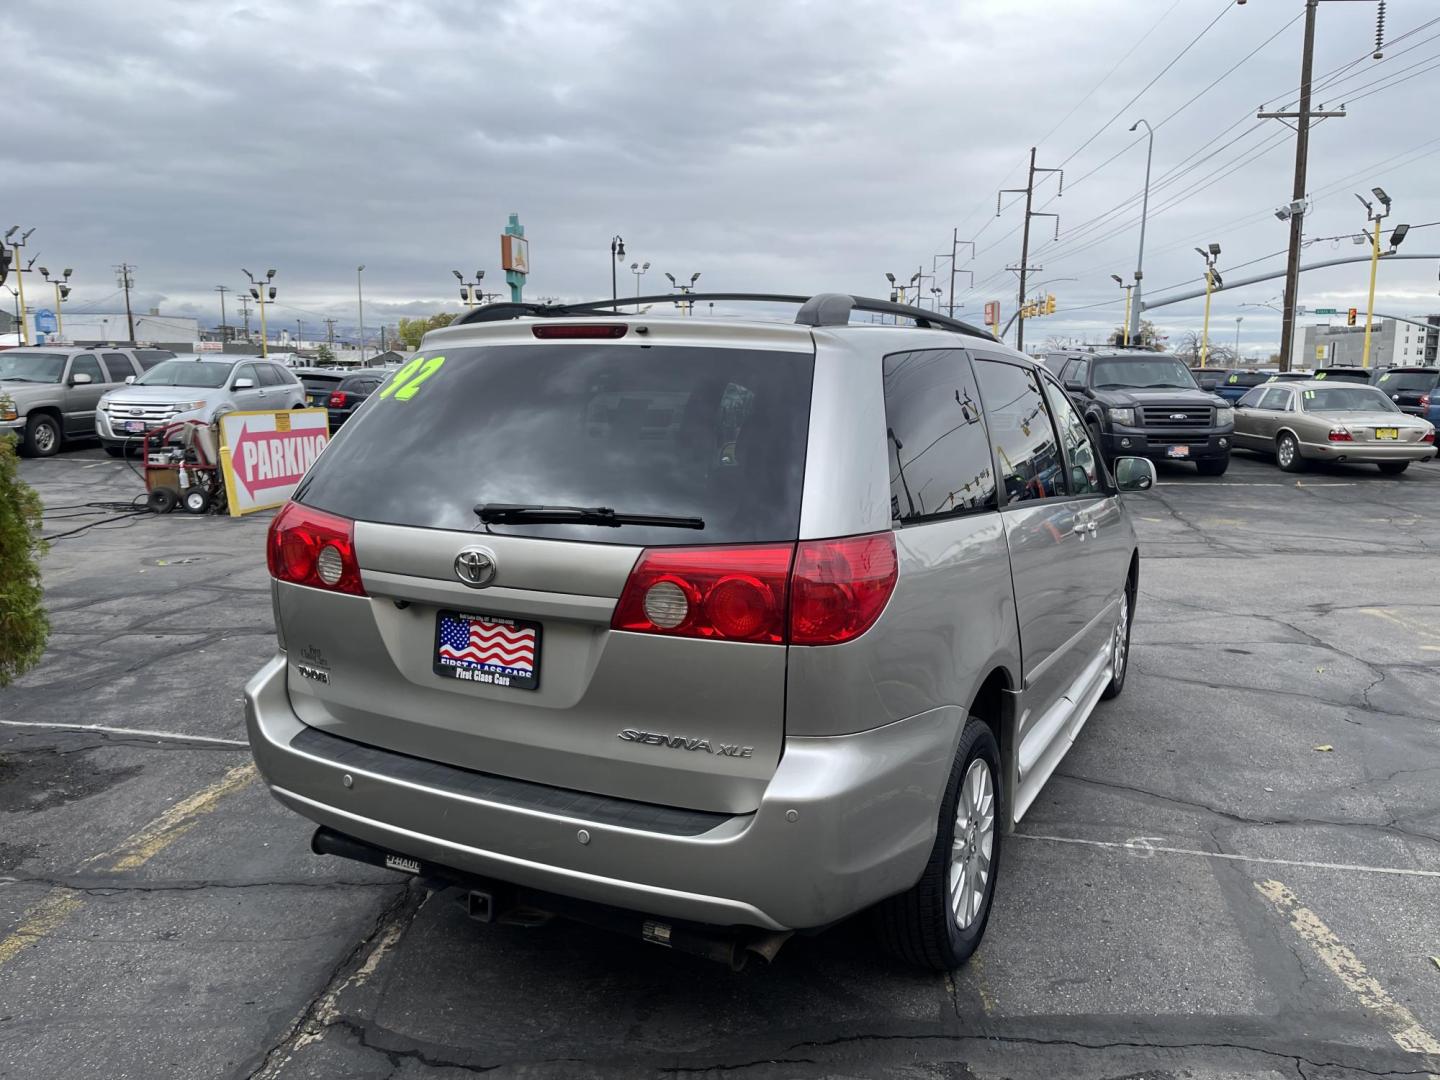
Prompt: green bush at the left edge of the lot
<box><xmin>0</xmin><ymin>435</ymin><xmax>50</xmax><ymax>687</ymax></box>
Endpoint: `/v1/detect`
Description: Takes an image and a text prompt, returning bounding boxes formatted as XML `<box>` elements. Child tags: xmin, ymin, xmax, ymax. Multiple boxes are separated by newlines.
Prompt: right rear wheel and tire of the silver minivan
<box><xmin>874</xmin><ymin>716</ymin><xmax>1005</xmax><ymax>971</ymax></box>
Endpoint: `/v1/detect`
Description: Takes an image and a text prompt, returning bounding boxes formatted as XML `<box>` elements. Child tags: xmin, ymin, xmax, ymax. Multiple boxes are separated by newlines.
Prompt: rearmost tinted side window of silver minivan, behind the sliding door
<box><xmin>884</xmin><ymin>348</ymin><xmax>996</xmax><ymax>523</ymax></box>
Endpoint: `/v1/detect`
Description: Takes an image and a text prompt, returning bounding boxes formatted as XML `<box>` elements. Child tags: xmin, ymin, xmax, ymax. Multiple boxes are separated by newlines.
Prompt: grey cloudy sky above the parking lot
<box><xmin>0</xmin><ymin>0</ymin><xmax>1440</xmax><ymax>348</ymax></box>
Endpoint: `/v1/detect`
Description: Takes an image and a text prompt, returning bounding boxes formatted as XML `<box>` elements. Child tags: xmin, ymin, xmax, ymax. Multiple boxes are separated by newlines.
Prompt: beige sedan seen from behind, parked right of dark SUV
<box><xmin>1236</xmin><ymin>380</ymin><xmax>1436</xmax><ymax>475</ymax></box>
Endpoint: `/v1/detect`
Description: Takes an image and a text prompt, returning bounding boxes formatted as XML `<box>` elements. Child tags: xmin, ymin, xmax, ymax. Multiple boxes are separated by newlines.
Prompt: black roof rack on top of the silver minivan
<box><xmin>451</xmin><ymin>292</ymin><xmax>999</xmax><ymax>341</ymax></box>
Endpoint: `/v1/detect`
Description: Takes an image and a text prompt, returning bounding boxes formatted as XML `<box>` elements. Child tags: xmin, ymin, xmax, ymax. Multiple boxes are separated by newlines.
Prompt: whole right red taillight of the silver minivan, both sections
<box><xmin>611</xmin><ymin>533</ymin><xmax>897</xmax><ymax>645</ymax></box>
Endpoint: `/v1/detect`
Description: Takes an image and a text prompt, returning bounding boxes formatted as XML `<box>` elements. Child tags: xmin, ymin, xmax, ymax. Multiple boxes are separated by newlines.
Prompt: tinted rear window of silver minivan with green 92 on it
<box><xmin>297</xmin><ymin>343</ymin><xmax>815</xmax><ymax>547</ymax></box>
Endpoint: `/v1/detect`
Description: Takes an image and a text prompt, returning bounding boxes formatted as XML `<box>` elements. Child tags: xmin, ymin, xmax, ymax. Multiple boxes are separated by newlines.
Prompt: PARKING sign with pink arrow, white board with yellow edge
<box><xmin>220</xmin><ymin>409</ymin><xmax>330</xmax><ymax>517</ymax></box>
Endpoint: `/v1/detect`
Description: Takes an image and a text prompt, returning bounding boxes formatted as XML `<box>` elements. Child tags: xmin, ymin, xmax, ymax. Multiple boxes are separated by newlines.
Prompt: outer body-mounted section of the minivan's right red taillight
<box><xmin>791</xmin><ymin>533</ymin><xmax>897</xmax><ymax>645</ymax></box>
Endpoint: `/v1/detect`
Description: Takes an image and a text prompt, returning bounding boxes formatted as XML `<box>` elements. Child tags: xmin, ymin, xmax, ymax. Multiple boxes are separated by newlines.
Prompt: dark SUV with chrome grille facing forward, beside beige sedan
<box><xmin>1060</xmin><ymin>353</ymin><xmax>1234</xmax><ymax>477</ymax></box>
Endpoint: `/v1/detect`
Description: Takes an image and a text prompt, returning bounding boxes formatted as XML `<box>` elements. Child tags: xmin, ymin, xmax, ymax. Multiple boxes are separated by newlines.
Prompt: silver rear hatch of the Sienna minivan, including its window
<box><xmin>276</xmin><ymin>324</ymin><xmax>814</xmax><ymax>812</ymax></box>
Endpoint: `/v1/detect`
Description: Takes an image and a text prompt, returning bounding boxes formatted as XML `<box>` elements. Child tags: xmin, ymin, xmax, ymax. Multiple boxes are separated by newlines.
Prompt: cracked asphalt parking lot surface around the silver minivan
<box><xmin>0</xmin><ymin>449</ymin><xmax>1440</xmax><ymax>1080</ymax></box>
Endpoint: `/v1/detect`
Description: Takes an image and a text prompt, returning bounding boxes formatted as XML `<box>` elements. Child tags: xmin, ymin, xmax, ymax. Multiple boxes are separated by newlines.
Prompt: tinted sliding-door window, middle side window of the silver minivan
<box><xmin>975</xmin><ymin>360</ymin><xmax>1067</xmax><ymax>503</ymax></box>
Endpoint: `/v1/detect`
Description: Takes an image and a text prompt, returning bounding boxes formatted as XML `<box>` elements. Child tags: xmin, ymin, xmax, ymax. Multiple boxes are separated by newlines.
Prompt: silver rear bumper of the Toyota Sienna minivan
<box><xmin>245</xmin><ymin>654</ymin><xmax>965</xmax><ymax>930</ymax></box>
